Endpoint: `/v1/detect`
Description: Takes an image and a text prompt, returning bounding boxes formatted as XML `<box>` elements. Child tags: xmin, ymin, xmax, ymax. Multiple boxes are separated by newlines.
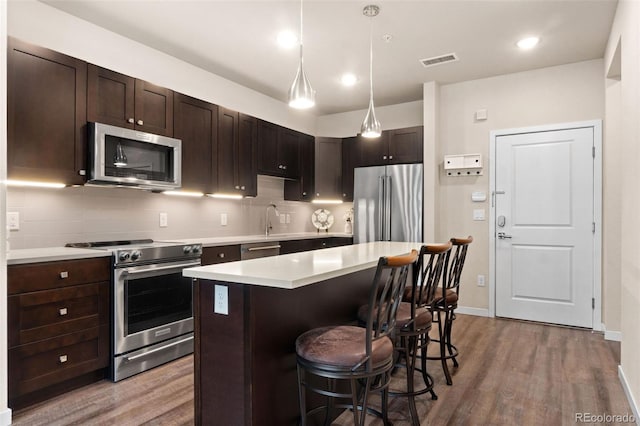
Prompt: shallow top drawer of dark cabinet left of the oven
<box><xmin>7</xmin><ymin>257</ymin><xmax>111</xmax><ymax>295</ymax></box>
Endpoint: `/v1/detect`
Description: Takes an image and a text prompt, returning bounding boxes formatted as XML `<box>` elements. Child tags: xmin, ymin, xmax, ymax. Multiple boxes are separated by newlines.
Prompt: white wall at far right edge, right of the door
<box><xmin>603</xmin><ymin>1</ymin><xmax>640</xmax><ymax>419</ymax></box>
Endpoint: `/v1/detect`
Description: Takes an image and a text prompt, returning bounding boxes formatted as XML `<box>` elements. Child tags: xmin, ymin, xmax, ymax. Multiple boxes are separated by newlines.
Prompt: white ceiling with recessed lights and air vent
<box><xmin>43</xmin><ymin>0</ymin><xmax>616</xmax><ymax>115</ymax></box>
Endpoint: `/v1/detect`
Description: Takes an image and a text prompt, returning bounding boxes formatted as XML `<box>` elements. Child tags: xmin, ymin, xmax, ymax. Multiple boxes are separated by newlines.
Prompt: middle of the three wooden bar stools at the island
<box><xmin>390</xmin><ymin>241</ymin><xmax>451</xmax><ymax>426</ymax></box>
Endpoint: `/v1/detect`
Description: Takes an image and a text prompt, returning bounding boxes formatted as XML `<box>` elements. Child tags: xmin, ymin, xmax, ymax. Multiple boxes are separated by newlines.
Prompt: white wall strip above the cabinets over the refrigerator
<box><xmin>316</xmin><ymin>99</ymin><xmax>423</xmax><ymax>138</ymax></box>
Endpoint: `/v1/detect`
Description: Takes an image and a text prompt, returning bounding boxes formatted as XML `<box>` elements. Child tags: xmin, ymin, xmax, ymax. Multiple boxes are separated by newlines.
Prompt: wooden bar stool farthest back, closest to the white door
<box><xmin>427</xmin><ymin>236</ymin><xmax>473</xmax><ymax>385</ymax></box>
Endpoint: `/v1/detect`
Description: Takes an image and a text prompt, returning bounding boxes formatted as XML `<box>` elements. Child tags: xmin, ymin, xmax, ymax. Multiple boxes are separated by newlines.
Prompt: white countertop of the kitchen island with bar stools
<box><xmin>183</xmin><ymin>241</ymin><xmax>423</xmax><ymax>289</ymax></box>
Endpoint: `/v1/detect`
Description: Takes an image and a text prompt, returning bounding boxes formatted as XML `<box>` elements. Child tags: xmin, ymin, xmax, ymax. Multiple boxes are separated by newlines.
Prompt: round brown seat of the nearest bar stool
<box><xmin>296</xmin><ymin>325</ymin><xmax>393</xmax><ymax>373</ymax></box>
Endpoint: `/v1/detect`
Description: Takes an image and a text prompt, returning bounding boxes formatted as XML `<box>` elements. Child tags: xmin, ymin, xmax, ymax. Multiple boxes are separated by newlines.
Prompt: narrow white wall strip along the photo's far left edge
<box><xmin>0</xmin><ymin>1</ymin><xmax>11</xmax><ymax>425</ymax></box>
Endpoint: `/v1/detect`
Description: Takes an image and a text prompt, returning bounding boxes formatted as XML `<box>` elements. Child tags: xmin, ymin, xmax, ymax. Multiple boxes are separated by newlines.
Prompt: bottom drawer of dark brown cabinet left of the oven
<box><xmin>8</xmin><ymin>325</ymin><xmax>109</xmax><ymax>399</ymax></box>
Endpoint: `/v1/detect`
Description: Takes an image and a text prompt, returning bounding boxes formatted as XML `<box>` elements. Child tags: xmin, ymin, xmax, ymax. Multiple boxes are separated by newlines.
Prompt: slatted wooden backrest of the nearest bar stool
<box><xmin>362</xmin><ymin>250</ymin><xmax>418</xmax><ymax>369</ymax></box>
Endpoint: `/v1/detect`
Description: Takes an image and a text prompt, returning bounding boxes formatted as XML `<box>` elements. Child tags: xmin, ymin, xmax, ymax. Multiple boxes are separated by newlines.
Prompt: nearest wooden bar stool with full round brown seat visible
<box><xmin>296</xmin><ymin>250</ymin><xmax>418</xmax><ymax>426</ymax></box>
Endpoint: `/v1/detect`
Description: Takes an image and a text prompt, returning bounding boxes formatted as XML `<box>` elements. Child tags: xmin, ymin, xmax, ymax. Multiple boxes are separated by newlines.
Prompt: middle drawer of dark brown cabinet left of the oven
<box><xmin>7</xmin><ymin>282</ymin><xmax>109</xmax><ymax>348</ymax></box>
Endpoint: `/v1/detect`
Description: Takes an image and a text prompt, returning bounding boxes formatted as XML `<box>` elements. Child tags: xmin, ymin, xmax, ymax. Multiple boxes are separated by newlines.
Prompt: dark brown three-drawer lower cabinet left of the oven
<box><xmin>7</xmin><ymin>258</ymin><xmax>110</xmax><ymax>410</ymax></box>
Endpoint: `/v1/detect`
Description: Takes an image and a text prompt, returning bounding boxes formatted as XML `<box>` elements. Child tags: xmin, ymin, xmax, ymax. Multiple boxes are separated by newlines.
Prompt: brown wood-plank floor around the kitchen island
<box><xmin>13</xmin><ymin>315</ymin><xmax>632</xmax><ymax>426</ymax></box>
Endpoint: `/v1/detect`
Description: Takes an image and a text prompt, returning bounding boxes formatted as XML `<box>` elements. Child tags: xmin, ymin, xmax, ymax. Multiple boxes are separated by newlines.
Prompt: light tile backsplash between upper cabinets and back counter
<box><xmin>7</xmin><ymin>176</ymin><xmax>352</xmax><ymax>249</ymax></box>
